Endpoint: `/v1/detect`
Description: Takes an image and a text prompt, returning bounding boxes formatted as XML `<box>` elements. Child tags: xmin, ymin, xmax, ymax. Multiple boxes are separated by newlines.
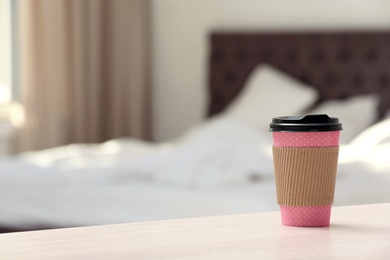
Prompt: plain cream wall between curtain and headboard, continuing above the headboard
<box><xmin>152</xmin><ymin>0</ymin><xmax>390</xmax><ymax>141</ymax></box>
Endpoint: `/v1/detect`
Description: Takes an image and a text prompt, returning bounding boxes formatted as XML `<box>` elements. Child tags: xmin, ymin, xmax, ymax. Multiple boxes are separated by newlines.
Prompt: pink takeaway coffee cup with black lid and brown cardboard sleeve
<box><xmin>270</xmin><ymin>114</ymin><xmax>342</xmax><ymax>227</ymax></box>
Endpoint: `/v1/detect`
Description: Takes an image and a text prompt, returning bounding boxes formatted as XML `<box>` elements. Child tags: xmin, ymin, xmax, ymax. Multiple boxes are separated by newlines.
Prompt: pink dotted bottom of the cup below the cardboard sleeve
<box><xmin>280</xmin><ymin>205</ymin><xmax>332</xmax><ymax>227</ymax></box>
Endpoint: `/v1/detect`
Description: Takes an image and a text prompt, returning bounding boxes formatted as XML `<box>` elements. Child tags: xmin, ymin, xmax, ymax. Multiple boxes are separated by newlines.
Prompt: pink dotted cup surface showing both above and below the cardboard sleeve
<box><xmin>272</xmin><ymin>131</ymin><xmax>340</xmax><ymax>227</ymax></box>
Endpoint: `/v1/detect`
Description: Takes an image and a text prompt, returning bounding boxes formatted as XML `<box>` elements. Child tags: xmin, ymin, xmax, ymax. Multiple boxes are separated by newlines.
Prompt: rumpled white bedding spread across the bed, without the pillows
<box><xmin>0</xmin><ymin>116</ymin><xmax>390</xmax><ymax>227</ymax></box>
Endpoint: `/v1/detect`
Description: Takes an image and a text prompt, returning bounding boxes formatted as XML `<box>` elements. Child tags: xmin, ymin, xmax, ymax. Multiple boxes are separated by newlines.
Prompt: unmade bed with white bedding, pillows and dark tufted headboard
<box><xmin>0</xmin><ymin>31</ymin><xmax>390</xmax><ymax>232</ymax></box>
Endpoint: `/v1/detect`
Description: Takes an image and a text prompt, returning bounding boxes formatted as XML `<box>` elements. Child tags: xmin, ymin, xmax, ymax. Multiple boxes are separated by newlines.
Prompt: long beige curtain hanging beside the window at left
<box><xmin>15</xmin><ymin>0</ymin><xmax>151</xmax><ymax>151</ymax></box>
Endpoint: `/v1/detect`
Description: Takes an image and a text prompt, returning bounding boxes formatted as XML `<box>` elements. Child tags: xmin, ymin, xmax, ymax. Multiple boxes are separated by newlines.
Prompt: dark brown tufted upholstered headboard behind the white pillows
<box><xmin>208</xmin><ymin>32</ymin><xmax>390</xmax><ymax>118</ymax></box>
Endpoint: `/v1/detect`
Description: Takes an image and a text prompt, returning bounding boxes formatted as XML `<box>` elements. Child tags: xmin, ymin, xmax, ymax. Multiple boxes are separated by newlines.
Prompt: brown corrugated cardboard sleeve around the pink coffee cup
<box><xmin>273</xmin><ymin>146</ymin><xmax>339</xmax><ymax>206</ymax></box>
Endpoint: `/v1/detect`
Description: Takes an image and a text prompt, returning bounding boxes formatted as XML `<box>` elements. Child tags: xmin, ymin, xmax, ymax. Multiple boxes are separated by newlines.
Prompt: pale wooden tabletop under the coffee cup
<box><xmin>0</xmin><ymin>204</ymin><xmax>390</xmax><ymax>259</ymax></box>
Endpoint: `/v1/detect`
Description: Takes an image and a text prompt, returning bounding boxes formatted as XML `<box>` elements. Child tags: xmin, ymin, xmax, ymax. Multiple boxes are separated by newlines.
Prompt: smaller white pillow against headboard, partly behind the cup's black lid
<box><xmin>309</xmin><ymin>95</ymin><xmax>379</xmax><ymax>144</ymax></box>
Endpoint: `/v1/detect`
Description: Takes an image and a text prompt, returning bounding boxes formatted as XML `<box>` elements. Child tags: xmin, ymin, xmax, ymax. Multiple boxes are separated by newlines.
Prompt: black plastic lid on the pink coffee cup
<box><xmin>269</xmin><ymin>114</ymin><xmax>343</xmax><ymax>132</ymax></box>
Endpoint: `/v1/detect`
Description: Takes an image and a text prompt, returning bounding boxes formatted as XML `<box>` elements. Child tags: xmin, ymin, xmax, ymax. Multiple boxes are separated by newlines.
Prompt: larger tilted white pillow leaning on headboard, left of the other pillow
<box><xmin>224</xmin><ymin>65</ymin><xmax>318</xmax><ymax>130</ymax></box>
